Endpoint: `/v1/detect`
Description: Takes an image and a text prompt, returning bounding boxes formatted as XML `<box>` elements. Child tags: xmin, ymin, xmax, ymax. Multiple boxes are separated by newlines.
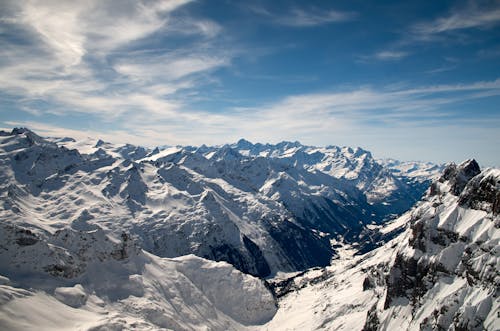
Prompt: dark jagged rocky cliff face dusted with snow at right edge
<box><xmin>381</xmin><ymin>160</ymin><xmax>500</xmax><ymax>330</ymax></box>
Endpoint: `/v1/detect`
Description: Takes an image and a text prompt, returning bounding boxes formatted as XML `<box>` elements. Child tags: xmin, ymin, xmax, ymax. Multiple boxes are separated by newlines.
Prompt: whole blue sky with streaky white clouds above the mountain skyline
<box><xmin>0</xmin><ymin>0</ymin><xmax>500</xmax><ymax>166</ymax></box>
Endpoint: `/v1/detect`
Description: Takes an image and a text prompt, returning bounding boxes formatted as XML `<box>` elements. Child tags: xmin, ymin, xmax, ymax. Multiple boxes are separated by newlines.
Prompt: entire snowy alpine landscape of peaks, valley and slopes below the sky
<box><xmin>0</xmin><ymin>129</ymin><xmax>500</xmax><ymax>330</ymax></box>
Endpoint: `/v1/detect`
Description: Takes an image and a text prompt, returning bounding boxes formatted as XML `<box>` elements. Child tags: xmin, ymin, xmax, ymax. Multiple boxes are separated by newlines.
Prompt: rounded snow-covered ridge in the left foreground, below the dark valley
<box><xmin>0</xmin><ymin>225</ymin><xmax>276</xmax><ymax>330</ymax></box>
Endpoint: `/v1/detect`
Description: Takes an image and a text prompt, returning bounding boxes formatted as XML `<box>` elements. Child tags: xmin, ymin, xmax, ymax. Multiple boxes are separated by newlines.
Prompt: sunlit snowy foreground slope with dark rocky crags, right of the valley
<box><xmin>266</xmin><ymin>161</ymin><xmax>500</xmax><ymax>330</ymax></box>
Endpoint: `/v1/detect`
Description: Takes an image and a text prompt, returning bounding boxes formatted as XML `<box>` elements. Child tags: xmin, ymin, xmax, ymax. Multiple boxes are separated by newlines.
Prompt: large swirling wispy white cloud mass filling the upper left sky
<box><xmin>0</xmin><ymin>0</ymin><xmax>232</xmax><ymax>121</ymax></box>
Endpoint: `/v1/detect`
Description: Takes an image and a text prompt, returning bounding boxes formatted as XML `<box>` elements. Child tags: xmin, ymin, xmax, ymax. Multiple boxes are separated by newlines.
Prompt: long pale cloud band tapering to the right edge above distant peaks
<box><xmin>203</xmin><ymin>80</ymin><xmax>500</xmax><ymax>143</ymax></box>
